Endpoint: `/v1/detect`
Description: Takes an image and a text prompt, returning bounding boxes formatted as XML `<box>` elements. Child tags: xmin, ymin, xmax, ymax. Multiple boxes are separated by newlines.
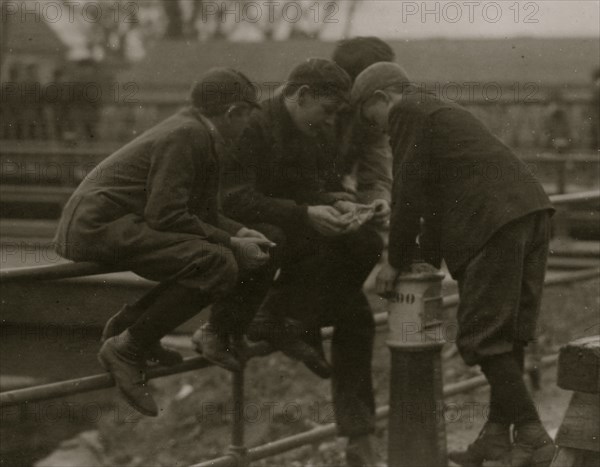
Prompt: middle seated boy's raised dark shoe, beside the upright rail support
<box><xmin>247</xmin><ymin>319</ymin><xmax>331</xmax><ymax>379</ymax></box>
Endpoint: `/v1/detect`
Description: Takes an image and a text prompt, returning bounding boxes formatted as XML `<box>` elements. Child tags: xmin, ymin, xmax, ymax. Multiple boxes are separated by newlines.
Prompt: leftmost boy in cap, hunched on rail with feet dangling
<box><xmin>55</xmin><ymin>68</ymin><xmax>274</xmax><ymax>416</ymax></box>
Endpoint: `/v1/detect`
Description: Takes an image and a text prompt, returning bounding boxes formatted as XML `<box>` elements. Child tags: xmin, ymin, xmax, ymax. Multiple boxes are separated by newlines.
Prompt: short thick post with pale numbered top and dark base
<box><xmin>387</xmin><ymin>272</ymin><xmax>447</xmax><ymax>467</ymax></box>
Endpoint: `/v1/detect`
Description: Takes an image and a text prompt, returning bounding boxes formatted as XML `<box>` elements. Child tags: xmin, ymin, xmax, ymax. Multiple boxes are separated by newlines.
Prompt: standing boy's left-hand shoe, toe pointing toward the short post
<box><xmin>448</xmin><ymin>422</ymin><xmax>511</xmax><ymax>467</ymax></box>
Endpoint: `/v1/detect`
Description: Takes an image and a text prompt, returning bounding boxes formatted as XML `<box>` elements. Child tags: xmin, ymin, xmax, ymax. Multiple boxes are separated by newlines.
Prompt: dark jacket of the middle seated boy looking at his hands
<box><xmin>222</xmin><ymin>95</ymin><xmax>342</xmax><ymax>227</ymax></box>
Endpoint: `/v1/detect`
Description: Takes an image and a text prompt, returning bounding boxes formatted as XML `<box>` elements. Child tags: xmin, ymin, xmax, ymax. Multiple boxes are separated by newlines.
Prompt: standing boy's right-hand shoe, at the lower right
<box><xmin>508</xmin><ymin>422</ymin><xmax>555</xmax><ymax>467</ymax></box>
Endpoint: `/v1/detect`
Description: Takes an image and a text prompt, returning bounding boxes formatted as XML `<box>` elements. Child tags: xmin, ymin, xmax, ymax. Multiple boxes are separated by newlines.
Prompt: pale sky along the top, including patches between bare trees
<box><xmin>23</xmin><ymin>0</ymin><xmax>600</xmax><ymax>58</ymax></box>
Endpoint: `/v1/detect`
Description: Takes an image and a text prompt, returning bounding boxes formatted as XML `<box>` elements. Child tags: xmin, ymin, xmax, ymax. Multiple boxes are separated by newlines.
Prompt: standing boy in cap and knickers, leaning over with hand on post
<box><xmin>352</xmin><ymin>63</ymin><xmax>553</xmax><ymax>467</ymax></box>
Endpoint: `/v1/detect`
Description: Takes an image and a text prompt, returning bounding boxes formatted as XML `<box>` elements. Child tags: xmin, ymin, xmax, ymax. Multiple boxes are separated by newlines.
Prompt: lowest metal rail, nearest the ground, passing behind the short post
<box><xmin>191</xmin><ymin>354</ymin><xmax>558</xmax><ymax>467</ymax></box>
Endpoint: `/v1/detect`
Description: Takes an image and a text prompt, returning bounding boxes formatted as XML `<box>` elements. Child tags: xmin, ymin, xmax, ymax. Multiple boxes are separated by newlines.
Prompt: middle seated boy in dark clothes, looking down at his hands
<box><xmin>223</xmin><ymin>59</ymin><xmax>382</xmax><ymax>466</ymax></box>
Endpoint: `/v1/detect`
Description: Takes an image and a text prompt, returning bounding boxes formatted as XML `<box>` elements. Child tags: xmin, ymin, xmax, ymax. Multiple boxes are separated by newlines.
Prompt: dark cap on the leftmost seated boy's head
<box><xmin>191</xmin><ymin>68</ymin><xmax>258</xmax><ymax>114</ymax></box>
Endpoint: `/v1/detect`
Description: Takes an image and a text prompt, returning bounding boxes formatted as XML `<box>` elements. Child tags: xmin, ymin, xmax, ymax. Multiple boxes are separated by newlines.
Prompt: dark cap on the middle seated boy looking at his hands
<box><xmin>287</xmin><ymin>58</ymin><xmax>352</xmax><ymax>101</ymax></box>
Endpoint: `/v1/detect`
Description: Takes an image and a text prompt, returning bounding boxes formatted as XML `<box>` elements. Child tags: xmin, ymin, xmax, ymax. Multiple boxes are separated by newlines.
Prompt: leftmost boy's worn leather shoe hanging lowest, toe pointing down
<box><xmin>98</xmin><ymin>331</ymin><xmax>158</xmax><ymax>417</ymax></box>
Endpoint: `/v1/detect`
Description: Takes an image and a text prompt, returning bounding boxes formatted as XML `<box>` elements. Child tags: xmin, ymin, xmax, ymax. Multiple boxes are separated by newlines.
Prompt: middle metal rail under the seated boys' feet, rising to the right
<box><xmin>0</xmin><ymin>268</ymin><xmax>600</xmax><ymax>407</ymax></box>
